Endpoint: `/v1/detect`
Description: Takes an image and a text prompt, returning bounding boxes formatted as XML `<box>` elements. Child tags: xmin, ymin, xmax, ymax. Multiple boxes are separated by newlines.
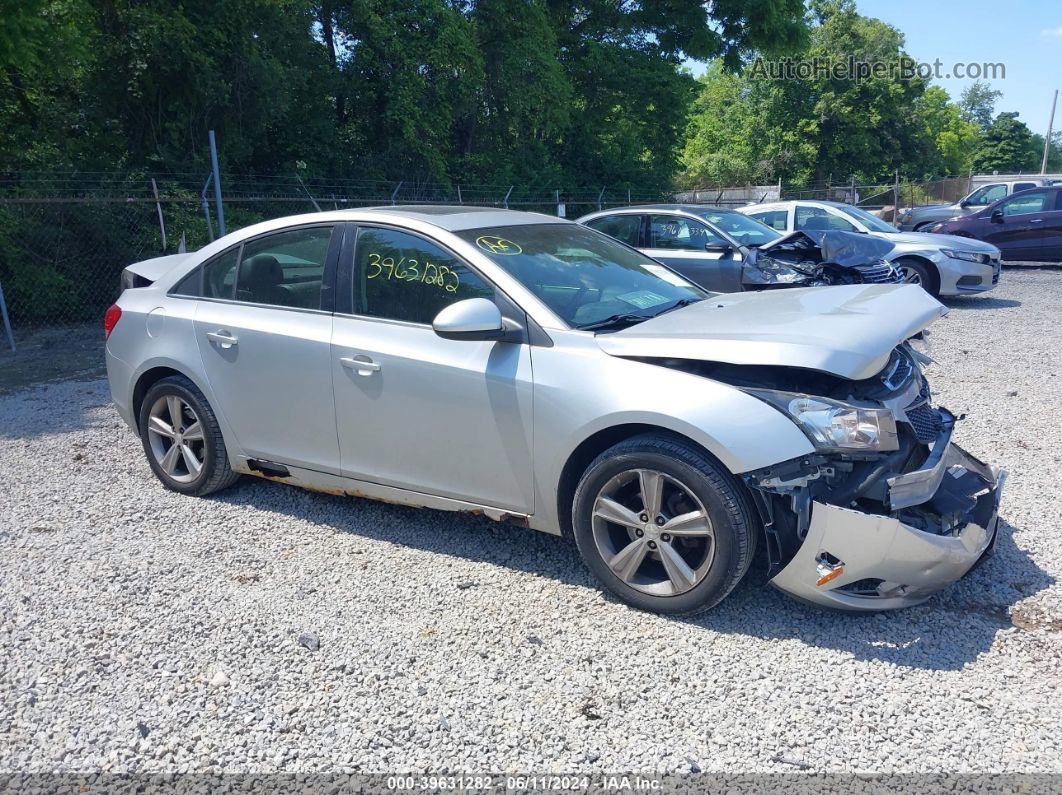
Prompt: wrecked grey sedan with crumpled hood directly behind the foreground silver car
<box><xmin>578</xmin><ymin>205</ymin><xmax>904</xmax><ymax>293</ymax></box>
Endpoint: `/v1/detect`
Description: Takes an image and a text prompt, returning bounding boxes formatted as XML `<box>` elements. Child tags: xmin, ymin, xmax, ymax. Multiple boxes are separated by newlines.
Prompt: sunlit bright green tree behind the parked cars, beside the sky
<box><xmin>681</xmin><ymin>0</ymin><xmax>943</xmax><ymax>185</ymax></box>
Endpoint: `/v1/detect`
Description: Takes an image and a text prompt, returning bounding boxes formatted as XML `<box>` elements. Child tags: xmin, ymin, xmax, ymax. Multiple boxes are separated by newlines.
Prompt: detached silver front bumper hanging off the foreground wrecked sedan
<box><xmin>751</xmin><ymin>415</ymin><xmax>1006</xmax><ymax>611</ymax></box>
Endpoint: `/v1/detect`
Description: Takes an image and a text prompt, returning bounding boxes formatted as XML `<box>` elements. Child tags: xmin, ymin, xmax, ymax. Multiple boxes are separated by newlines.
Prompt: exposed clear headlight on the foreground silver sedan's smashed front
<box><xmin>748</xmin><ymin>390</ymin><xmax>900</xmax><ymax>451</ymax></box>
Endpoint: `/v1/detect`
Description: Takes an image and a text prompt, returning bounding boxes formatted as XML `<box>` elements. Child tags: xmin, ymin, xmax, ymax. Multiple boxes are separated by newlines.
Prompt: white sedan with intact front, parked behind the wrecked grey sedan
<box><xmin>737</xmin><ymin>201</ymin><xmax>1000</xmax><ymax>296</ymax></box>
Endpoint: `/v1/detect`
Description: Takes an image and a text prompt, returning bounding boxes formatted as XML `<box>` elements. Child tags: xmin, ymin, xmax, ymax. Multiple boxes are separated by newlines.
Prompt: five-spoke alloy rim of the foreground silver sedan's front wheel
<box><xmin>592</xmin><ymin>469</ymin><xmax>716</xmax><ymax>597</ymax></box>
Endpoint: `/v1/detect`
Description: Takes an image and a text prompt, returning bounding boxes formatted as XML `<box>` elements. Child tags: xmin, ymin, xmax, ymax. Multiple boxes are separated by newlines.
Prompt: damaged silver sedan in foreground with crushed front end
<box><xmin>104</xmin><ymin>207</ymin><xmax>1003</xmax><ymax>613</ymax></box>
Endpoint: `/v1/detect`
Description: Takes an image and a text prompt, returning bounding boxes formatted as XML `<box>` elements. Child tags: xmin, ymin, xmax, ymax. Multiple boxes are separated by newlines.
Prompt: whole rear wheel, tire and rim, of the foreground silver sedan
<box><xmin>139</xmin><ymin>376</ymin><xmax>239</xmax><ymax>497</ymax></box>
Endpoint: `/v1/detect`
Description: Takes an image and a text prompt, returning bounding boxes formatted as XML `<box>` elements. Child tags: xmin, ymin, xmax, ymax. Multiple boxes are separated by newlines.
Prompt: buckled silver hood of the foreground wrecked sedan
<box><xmin>597</xmin><ymin>284</ymin><xmax>947</xmax><ymax>380</ymax></box>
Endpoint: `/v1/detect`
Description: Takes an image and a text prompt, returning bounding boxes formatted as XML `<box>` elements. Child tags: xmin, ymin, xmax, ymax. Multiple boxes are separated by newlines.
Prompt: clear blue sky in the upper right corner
<box><xmin>856</xmin><ymin>0</ymin><xmax>1062</xmax><ymax>135</ymax></box>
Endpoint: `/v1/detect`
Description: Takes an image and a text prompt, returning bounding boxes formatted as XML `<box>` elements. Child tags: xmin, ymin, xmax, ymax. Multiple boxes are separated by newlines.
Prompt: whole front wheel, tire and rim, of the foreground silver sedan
<box><xmin>572</xmin><ymin>434</ymin><xmax>755</xmax><ymax>613</ymax></box>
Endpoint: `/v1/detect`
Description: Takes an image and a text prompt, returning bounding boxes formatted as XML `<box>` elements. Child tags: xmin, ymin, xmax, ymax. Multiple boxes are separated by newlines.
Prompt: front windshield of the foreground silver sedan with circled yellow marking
<box><xmin>457</xmin><ymin>224</ymin><xmax>707</xmax><ymax>328</ymax></box>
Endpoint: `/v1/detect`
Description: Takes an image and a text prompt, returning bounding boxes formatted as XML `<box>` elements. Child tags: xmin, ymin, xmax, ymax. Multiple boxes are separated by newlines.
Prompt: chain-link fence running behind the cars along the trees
<box><xmin>0</xmin><ymin>173</ymin><xmax>981</xmax><ymax>334</ymax></box>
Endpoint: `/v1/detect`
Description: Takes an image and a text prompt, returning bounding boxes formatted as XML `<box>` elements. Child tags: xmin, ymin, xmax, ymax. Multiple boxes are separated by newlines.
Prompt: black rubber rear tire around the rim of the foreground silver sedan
<box><xmin>137</xmin><ymin>376</ymin><xmax>240</xmax><ymax>497</ymax></box>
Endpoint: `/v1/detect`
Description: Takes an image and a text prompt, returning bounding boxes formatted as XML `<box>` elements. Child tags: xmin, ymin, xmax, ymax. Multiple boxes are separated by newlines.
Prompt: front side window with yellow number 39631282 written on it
<box><xmin>352</xmin><ymin>227</ymin><xmax>494</xmax><ymax>325</ymax></box>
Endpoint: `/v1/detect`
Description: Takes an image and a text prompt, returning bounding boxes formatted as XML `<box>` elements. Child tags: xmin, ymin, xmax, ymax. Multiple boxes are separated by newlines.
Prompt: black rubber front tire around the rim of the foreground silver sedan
<box><xmin>572</xmin><ymin>433</ymin><xmax>758</xmax><ymax>615</ymax></box>
